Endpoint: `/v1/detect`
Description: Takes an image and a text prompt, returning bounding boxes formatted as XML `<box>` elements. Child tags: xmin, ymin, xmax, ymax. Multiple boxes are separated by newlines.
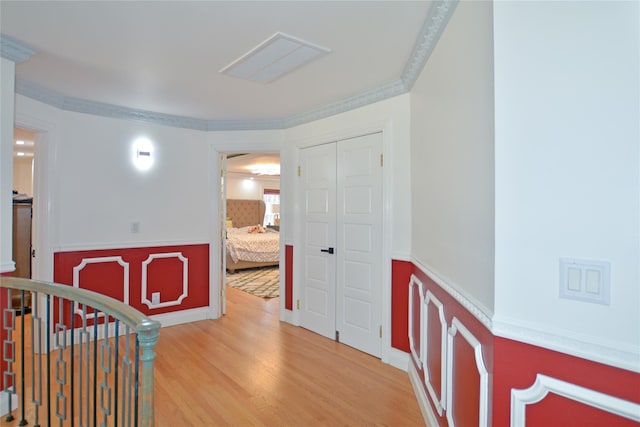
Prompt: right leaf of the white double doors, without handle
<box><xmin>336</xmin><ymin>133</ymin><xmax>382</xmax><ymax>357</ymax></box>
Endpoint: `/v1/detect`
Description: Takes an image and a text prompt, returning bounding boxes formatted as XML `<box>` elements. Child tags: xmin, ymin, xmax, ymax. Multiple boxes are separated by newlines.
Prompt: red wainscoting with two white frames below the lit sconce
<box><xmin>54</xmin><ymin>244</ymin><xmax>209</xmax><ymax>315</ymax></box>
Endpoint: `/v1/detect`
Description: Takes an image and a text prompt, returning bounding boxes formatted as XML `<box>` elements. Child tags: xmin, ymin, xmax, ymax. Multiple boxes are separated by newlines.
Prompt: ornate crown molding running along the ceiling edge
<box><xmin>10</xmin><ymin>0</ymin><xmax>458</xmax><ymax>131</ymax></box>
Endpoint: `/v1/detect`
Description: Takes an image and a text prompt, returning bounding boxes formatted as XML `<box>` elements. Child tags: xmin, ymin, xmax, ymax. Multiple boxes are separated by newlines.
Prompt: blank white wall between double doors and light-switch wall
<box><xmin>411</xmin><ymin>2</ymin><xmax>494</xmax><ymax>316</ymax></box>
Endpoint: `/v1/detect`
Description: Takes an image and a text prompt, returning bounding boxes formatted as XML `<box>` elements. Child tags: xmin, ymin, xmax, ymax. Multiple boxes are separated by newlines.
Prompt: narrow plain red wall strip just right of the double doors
<box><xmin>391</xmin><ymin>260</ymin><xmax>413</xmax><ymax>353</ymax></box>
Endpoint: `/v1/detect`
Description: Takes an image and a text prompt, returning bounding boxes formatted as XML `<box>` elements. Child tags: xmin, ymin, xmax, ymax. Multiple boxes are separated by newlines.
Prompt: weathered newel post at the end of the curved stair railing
<box><xmin>138</xmin><ymin>320</ymin><xmax>160</xmax><ymax>427</ymax></box>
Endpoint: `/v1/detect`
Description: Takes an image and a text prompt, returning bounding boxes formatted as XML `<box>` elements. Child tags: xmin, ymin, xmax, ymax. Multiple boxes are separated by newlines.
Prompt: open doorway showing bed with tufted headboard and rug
<box><xmin>220</xmin><ymin>152</ymin><xmax>280</xmax><ymax>314</ymax></box>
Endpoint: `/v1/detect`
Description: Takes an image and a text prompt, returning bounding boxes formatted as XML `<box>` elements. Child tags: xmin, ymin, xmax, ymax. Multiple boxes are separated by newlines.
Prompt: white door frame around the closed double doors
<box><xmin>290</xmin><ymin>119</ymin><xmax>393</xmax><ymax>364</ymax></box>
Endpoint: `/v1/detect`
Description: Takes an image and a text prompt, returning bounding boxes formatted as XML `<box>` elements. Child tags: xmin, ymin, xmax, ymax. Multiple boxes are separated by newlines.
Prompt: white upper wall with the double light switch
<box><xmin>494</xmin><ymin>1</ymin><xmax>640</xmax><ymax>369</ymax></box>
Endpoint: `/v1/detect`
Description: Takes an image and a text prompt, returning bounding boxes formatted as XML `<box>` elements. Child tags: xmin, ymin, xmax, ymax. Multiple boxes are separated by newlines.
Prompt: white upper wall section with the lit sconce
<box><xmin>16</xmin><ymin>96</ymin><xmax>211</xmax><ymax>250</ymax></box>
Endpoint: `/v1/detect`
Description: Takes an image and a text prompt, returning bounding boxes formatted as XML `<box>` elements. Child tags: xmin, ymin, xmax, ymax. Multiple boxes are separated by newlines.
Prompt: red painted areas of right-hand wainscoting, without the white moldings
<box><xmin>391</xmin><ymin>261</ymin><xmax>640</xmax><ymax>427</ymax></box>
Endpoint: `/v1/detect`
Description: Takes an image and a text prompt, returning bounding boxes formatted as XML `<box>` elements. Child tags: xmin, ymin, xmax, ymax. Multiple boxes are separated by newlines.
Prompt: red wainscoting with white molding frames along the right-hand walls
<box><xmin>391</xmin><ymin>261</ymin><xmax>640</xmax><ymax>427</ymax></box>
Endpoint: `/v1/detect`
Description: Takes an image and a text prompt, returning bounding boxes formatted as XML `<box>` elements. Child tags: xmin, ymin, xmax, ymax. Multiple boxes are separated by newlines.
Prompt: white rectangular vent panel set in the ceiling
<box><xmin>220</xmin><ymin>33</ymin><xmax>331</xmax><ymax>83</ymax></box>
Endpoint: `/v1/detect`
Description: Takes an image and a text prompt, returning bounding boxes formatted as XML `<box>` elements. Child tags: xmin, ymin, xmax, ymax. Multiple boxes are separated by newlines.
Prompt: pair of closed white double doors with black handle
<box><xmin>300</xmin><ymin>134</ymin><xmax>382</xmax><ymax>357</ymax></box>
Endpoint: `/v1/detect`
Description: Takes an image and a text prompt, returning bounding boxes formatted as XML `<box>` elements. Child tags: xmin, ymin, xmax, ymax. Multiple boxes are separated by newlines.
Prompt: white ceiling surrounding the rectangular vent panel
<box><xmin>0</xmin><ymin>0</ymin><xmax>433</xmax><ymax>122</ymax></box>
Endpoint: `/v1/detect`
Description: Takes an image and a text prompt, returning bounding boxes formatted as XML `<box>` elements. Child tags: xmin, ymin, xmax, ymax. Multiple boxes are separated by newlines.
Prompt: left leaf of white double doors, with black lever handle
<box><xmin>300</xmin><ymin>144</ymin><xmax>336</xmax><ymax>338</ymax></box>
